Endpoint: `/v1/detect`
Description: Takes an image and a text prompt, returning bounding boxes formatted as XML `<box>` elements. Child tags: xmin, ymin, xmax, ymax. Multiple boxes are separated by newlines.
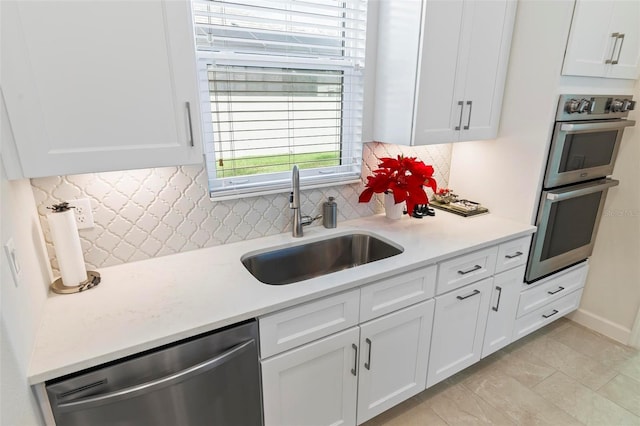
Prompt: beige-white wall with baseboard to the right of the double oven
<box><xmin>572</xmin><ymin>83</ymin><xmax>640</xmax><ymax>343</ymax></box>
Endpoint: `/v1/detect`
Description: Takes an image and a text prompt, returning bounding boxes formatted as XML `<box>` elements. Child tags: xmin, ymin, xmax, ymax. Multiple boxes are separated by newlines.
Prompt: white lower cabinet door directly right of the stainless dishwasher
<box><xmin>262</xmin><ymin>327</ymin><xmax>359</xmax><ymax>426</ymax></box>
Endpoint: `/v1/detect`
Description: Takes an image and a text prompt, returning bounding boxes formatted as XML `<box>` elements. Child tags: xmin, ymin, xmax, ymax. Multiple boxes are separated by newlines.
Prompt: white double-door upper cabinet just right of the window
<box><xmin>374</xmin><ymin>0</ymin><xmax>516</xmax><ymax>145</ymax></box>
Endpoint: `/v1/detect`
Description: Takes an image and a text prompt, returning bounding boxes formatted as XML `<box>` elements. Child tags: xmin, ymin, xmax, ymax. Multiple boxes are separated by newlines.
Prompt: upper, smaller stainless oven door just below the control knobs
<box><xmin>544</xmin><ymin>120</ymin><xmax>635</xmax><ymax>188</ymax></box>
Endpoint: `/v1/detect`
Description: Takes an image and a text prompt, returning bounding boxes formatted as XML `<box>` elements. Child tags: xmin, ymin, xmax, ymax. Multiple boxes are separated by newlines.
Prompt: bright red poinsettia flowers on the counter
<box><xmin>358</xmin><ymin>155</ymin><xmax>437</xmax><ymax>213</ymax></box>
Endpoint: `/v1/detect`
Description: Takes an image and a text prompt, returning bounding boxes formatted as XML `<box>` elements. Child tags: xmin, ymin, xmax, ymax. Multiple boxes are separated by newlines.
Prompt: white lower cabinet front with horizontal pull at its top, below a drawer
<box><xmin>427</xmin><ymin>278</ymin><xmax>493</xmax><ymax>387</ymax></box>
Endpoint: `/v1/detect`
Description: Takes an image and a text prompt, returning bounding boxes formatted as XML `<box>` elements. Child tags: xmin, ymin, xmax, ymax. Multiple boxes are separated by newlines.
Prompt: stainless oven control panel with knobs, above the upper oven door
<box><xmin>556</xmin><ymin>95</ymin><xmax>636</xmax><ymax>121</ymax></box>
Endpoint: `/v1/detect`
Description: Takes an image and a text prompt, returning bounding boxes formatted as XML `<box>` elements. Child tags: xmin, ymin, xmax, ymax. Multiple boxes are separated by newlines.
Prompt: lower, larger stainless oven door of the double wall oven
<box><xmin>526</xmin><ymin>179</ymin><xmax>619</xmax><ymax>282</ymax></box>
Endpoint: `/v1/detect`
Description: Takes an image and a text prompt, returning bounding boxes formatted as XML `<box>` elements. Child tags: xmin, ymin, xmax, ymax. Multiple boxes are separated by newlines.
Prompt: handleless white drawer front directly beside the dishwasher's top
<box><xmin>258</xmin><ymin>290</ymin><xmax>360</xmax><ymax>358</ymax></box>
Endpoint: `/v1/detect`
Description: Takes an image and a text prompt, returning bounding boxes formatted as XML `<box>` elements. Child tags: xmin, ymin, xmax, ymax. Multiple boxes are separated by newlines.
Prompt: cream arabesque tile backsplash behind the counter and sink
<box><xmin>31</xmin><ymin>142</ymin><xmax>451</xmax><ymax>274</ymax></box>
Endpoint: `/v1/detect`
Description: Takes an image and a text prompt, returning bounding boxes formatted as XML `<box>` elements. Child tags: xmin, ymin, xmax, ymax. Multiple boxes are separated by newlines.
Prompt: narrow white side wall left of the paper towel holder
<box><xmin>0</xmin><ymin>92</ymin><xmax>51</xmax><ymax>426</ymax></box>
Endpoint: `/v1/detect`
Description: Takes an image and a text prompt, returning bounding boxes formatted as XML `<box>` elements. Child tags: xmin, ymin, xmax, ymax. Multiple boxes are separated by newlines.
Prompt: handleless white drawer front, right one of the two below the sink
<box><xmin>360</xmin><ymin>265</ymin><xmax>437</xmax><ymax>322</ymax></box>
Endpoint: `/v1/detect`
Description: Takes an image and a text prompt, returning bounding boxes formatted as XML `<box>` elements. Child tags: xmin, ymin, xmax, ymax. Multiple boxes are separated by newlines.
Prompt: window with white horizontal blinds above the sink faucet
<box><xmin>193</xmin><ymin>0</ymin><xmax>367</xmax><ymax>198</ymax></box>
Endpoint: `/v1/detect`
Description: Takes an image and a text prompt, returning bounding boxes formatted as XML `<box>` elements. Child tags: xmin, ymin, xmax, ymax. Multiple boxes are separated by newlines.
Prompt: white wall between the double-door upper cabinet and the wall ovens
<box><xmin>449</xmin><ymin>0</ymin><xmax>573</xmax><ymax>223</ymax></box>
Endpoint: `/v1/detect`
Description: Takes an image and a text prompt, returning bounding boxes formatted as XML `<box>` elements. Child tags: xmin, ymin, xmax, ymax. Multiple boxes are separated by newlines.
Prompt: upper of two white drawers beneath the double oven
<box><xmin>518</xmin><ymin>263</ymin><xmax>588</xmax><ymax>318</ymax></box>
